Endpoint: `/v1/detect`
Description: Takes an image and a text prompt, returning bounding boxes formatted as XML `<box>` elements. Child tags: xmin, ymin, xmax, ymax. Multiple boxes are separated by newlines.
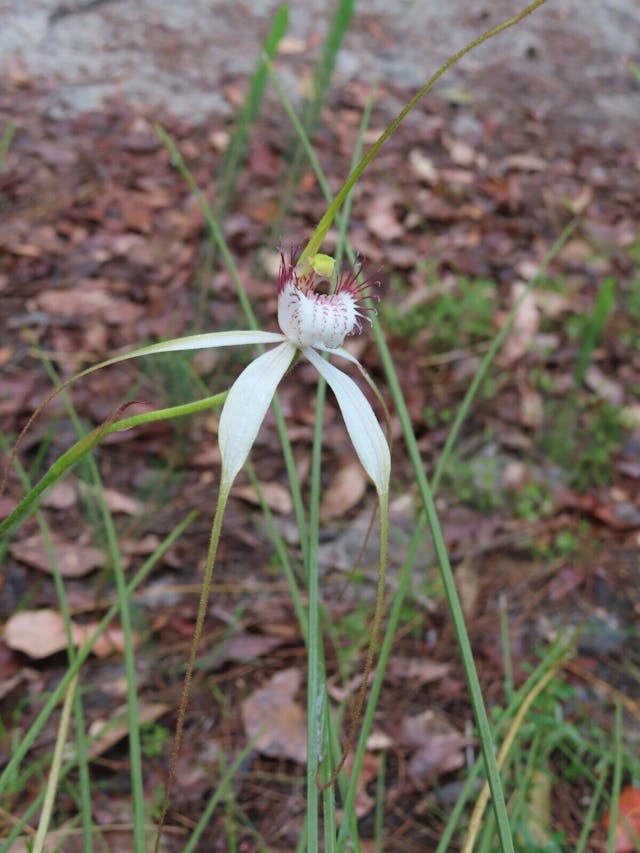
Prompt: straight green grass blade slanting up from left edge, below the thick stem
<box><xmin>0</xmin><ymin>512</ymin><xmax>197</xmax><ymax>796</ymax></box>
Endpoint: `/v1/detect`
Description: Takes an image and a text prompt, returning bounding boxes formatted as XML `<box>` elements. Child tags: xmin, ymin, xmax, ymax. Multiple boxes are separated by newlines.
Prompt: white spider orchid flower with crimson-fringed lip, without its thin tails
<box><xmin>127</xmin><ymin>246</ymin><xmax>391</xmax><ymax>495</ymax></box>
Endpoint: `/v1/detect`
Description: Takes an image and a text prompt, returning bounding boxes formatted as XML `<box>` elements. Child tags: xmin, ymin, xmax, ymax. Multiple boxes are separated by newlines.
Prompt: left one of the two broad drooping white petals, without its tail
<box><xmin>218</xmin><ymin>341</ymin><xmax>296</xmax><ymax>490</ymax></box>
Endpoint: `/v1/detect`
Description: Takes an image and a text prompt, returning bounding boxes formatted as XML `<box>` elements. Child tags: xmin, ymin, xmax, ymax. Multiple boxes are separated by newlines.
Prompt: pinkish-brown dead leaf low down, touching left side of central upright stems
<box><xmin>242</xmin><ymin>669</ymin><xmax>307</xmax><ymax>764</ymax></box>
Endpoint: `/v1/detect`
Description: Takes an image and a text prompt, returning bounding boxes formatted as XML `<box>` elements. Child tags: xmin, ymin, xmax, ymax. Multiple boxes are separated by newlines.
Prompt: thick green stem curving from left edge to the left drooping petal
<box><xmin>0</xmin><ymin>391</ymin><xmax>228</xmax><ymax>536</ymax></box>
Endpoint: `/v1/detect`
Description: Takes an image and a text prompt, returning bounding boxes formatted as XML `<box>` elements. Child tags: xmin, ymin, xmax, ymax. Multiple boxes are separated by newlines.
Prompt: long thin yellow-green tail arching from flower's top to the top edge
<box><xmin>299</xmin><ymin>0</ymin><xmax>545</xmax><ymax>261</ymax></box>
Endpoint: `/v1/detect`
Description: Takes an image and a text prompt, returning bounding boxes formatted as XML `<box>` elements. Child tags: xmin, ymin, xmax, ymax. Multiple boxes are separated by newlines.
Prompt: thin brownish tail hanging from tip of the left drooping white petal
<box><xmin>154</xmin><ymin>482</ymin><xmax>232</xmax><ymax>853</ymax></box>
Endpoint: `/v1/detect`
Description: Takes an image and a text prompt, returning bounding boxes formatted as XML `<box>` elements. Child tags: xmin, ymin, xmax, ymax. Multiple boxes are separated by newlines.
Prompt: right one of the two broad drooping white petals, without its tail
<box><xmin>303</xmin><ymin>347</ymin><xmax>391</xmax><ymax>494</ymax></box>
